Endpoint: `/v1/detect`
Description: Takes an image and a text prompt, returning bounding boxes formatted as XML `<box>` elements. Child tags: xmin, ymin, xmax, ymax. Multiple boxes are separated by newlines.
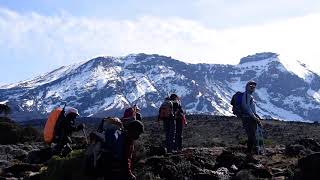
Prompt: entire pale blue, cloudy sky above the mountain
<box><xmin>0</xmin><ymin>0</ymin><xmax>320</xmax><ymax>85</ymax></box>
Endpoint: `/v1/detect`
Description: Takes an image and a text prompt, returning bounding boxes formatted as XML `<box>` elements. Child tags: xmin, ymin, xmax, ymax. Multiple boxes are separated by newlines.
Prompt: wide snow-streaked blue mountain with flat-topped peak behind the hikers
<box><xmin>0</xmin><ymin>53</ymin><xmax>320</xmax><ymax>121</ymax></box>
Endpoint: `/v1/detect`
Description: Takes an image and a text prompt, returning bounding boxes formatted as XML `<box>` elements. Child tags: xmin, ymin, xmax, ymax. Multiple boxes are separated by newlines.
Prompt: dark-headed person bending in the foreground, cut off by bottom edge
<box><xmin>104</xmin><ymin>120</ymin><xmax>144</xmax><ymax>180</ymax></box>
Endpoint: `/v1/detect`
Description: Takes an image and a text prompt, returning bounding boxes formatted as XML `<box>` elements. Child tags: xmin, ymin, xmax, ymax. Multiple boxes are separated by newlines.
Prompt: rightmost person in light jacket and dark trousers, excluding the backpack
<box><xmin>241</xmin><ymin>80</ymin><xmax>261</xmax><ymax>154</ymax></box>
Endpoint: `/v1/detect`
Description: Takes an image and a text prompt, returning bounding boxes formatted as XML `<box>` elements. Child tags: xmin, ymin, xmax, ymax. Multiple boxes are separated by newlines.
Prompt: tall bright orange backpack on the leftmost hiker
<box><xmin>43</xmin><ymin>107</ymin><xmax>64</xmax><ymax>144</ymax></box>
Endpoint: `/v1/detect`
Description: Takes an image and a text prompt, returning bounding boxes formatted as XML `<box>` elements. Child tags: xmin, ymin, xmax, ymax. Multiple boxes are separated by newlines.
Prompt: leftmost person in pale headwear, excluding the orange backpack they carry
<box><xmin>54</xmin><ymin>107</ymin><xmax>85</xmax><ymax>156</ymax></box>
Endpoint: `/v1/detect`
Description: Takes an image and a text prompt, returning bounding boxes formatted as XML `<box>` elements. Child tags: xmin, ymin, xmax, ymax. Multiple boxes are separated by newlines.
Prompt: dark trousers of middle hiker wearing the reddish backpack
<box><xmin>163</xmin><ymin>119</ymin><xmax>175</xmax><ymax>152</ymax></box>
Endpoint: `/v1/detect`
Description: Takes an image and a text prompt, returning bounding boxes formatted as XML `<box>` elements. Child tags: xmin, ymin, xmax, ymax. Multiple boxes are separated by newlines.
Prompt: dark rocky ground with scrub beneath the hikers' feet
<box><xmin>0</xmin><ymin>116</ymin><xmax>320</xmax><ymax>180</ymax></box>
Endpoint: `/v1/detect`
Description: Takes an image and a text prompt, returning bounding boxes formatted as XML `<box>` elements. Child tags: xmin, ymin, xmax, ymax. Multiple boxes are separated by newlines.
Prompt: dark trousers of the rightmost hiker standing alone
<box><xmin>242</xmin><ymin>117</ymin><xmax>257</xmax><ymax>153</ymax></box>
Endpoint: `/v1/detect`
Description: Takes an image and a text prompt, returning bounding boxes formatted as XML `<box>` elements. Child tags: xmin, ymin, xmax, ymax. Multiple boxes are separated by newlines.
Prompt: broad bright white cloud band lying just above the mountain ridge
<box><xmin>0</xmin><ymin>6</ymin><xmax>320</xmax><ymax>83</ymax></box>
